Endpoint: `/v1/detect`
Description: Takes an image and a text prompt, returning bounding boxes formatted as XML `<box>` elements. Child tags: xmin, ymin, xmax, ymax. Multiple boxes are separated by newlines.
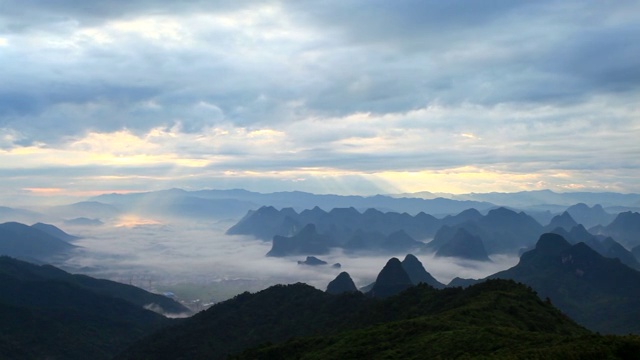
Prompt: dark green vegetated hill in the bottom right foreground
<box><xmin>236</xmin><ymin>283</ymin><xmax>640</xmax><ymax>360</ymax></box>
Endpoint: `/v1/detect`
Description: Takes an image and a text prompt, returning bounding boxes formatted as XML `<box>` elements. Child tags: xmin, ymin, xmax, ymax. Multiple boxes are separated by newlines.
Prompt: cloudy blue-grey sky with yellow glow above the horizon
<box><xmin>0</xmin><ymin>0</ymin><xmax>640</xmax><ymax>205</ymax></box>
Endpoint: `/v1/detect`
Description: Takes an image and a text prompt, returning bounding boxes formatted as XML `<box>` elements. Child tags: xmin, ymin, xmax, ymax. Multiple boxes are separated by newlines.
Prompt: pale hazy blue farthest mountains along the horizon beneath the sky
<box><xmin>0</xmin><ymin>189</ymin><xmax>640</xmax><ymax>228</ymax></box>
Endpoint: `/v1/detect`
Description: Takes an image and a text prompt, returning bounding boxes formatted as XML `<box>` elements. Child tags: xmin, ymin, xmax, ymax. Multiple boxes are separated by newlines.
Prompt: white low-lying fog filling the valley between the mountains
<box><xmin>57</xmin><ymin>218</ymin><xmax>518</xmax><ymax>304</ymax></box>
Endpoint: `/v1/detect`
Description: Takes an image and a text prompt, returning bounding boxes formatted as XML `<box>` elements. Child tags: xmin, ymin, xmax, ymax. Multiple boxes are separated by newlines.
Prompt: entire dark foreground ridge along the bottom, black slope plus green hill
<box><xmin>118</xmin><ymin>280</ymin><xmax>640</xmax><ymax>359</ymax></box>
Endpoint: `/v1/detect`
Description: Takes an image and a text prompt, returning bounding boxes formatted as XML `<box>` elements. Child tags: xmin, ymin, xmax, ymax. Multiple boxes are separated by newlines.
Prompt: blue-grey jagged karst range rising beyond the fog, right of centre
<box><xmin>232</xmin><ymin>206</ymin><xmax>543</xmax><ymax>261</ymax></box>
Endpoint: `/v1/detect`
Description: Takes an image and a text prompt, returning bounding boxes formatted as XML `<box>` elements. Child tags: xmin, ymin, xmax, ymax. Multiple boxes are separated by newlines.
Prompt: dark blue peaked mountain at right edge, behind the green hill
<box><xmin>490</xmin><ymin>234</ymin><xmax>640</xmax><ymax>334</ymax></box>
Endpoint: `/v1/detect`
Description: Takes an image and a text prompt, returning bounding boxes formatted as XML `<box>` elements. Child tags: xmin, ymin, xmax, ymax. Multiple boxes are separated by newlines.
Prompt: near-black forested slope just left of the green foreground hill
<box><xmin>117</xmin><ymin>284</ymin><xmax>373</xmax><ymax>360</ymax></box>
